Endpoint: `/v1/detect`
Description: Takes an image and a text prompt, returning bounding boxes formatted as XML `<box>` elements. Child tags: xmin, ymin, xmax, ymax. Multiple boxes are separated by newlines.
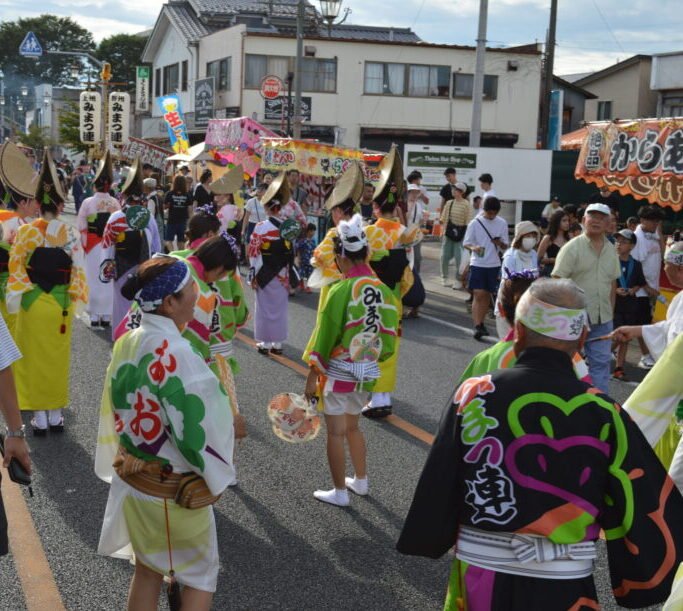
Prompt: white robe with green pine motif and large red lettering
<box><xmin>95</xmin><ymin>313</ymin><xmax>236</xmax><ymax>592</ymax></box>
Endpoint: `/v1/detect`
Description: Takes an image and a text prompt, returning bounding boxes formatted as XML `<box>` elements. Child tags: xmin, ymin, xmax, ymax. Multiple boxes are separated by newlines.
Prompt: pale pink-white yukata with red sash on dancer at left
<box><xmin>77</xmin><ymin>192</ymin><xmax>121</xmax><ymax>322</ymax></box>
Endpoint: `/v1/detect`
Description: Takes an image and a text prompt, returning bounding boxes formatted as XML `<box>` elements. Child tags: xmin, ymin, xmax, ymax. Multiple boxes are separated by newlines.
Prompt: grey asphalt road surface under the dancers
<box><xmin>0</xmin><ymin>231</ymin><xmax>664</xmax><ymax>611</ymax></box>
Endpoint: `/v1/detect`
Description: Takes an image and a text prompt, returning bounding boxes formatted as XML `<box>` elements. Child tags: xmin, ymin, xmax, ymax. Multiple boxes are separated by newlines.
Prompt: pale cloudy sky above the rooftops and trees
<box><xmin>0</xmin><ymin>0</ymin><xmax>683</xmax><ymax>75</ymax></box>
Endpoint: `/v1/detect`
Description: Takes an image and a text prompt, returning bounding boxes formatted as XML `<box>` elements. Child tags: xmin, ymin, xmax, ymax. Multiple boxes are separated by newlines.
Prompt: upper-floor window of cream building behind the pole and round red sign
<box><xmin>244</xmin><ymin>54</ymin><xmax>337</xmax><ymax>93</ymax></box>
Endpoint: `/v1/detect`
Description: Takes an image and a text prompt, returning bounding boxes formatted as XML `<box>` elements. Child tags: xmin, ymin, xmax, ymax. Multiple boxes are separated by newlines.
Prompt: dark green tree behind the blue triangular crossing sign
<box><xmin>0</xmin><ymin>15</ymin><xmax>95</xmax><ymax>95</ymax></box>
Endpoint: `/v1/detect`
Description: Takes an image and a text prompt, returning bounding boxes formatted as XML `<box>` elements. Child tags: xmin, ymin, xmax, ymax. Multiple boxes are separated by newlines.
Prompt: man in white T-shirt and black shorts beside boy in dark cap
<box><xmin>631</xmin><ymin>206</ymin><xmax>662</xmax><ymax>369</ymax></box>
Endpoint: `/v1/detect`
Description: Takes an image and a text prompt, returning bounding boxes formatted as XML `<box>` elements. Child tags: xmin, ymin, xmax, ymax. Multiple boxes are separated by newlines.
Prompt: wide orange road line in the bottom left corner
<box><xmin>0</xmin><ymin>467</ymin><xmax>66</xmax><ymax>611</ymax></box>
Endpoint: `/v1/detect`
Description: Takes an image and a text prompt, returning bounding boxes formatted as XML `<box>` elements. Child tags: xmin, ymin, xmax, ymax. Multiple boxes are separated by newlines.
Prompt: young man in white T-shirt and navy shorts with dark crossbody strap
<box><xmin>463</xmin><ymin>197</ymin><xmax>510</xmax><ymax>340</ymax></box>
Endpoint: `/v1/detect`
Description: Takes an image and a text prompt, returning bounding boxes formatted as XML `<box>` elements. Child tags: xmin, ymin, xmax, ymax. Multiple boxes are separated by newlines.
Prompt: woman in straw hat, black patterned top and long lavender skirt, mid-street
<box><xmin>247</xmin><ymin>173</ymin><xmax>300</xmax><ymax>355</ymax></box>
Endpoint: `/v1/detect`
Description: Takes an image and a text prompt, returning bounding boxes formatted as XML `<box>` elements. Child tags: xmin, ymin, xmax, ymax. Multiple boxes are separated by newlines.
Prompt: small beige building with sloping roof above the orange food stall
<box><xmin>565</xmin><ymin>55</ymin><xmax>657</xmax><ymax>121</ymax></box>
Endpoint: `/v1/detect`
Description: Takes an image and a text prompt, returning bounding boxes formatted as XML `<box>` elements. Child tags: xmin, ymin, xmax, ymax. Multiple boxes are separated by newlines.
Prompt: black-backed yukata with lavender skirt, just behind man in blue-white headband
<box><xmin>102</xmin><ymin>206</ymin><xmax>161</xmax><ymax>337</ymax></box>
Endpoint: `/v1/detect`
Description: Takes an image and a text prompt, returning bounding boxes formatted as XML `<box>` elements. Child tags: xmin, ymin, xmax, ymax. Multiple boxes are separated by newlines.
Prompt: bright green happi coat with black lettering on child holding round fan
<box><xmin>304</xmin><ymin>263</ymin><xmax>400</xmax><ymax>412</ymax></box>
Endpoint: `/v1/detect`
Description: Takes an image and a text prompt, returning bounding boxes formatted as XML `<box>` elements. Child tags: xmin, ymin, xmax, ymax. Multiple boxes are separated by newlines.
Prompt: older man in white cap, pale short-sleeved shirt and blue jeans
<box><xmin>553</xmin><ymin>204</ymin><xmax>621</xmax><ymax>392</ymax></box>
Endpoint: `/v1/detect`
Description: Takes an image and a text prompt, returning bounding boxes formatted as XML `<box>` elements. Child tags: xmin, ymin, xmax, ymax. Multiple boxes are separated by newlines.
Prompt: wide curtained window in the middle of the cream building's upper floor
<box><xmin>364</xmin><ymin>62</ymin><xmax>450</xmax><ymax>97</ymax></box>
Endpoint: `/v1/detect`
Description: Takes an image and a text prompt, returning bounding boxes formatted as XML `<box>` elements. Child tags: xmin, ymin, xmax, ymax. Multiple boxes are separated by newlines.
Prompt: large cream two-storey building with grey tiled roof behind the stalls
<box><xmin>142</xmin><ymin>0</ymin><xmax>541</xmax><ymax>150</ymax></box>
